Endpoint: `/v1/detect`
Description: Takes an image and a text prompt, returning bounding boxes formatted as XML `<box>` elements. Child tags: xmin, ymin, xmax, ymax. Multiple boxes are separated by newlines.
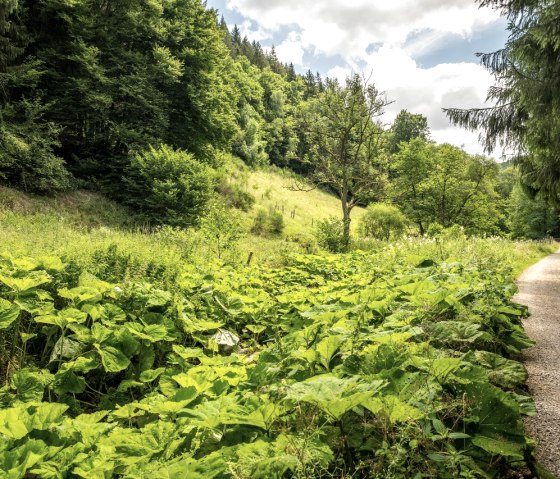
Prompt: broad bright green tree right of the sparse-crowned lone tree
<box><xmin>391</xmin><ymin>138</ymin><xmax>501</xmax><ymax>235</ymax></box>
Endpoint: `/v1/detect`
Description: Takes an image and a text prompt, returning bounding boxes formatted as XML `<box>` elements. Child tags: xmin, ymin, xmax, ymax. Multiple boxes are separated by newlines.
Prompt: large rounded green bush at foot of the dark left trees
<box><xmin>124</xmin><ymin>145</ymin><xmax>215</xmax><ymax>227</ymax></box>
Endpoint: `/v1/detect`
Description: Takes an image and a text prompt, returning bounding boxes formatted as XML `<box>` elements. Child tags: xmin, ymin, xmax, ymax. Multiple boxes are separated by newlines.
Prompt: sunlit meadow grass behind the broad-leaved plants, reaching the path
<box><xmin>0</xmin><ymin>169</ymin><xmax>558</xmax><ymax>282</ymax></box>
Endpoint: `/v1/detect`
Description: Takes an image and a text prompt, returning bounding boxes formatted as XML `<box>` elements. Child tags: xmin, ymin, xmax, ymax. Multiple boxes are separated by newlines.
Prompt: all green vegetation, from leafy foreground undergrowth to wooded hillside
<box><xmin>0</xmin><ymin>0</ymin><xmax>560</xmax><ymax>479</ymax></box>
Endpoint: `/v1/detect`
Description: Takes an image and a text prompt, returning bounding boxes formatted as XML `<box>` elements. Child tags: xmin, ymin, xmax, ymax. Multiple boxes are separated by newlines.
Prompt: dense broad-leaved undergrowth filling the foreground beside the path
<box><xmin>0</xmin><ymin>239</ymin><xmax>554</xmax><ymax>479</ymax></box>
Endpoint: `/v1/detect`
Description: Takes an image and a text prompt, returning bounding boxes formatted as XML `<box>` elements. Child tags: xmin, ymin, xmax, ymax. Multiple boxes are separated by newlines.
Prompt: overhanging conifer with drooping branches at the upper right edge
<box><xmin>447</xmin><ymin>0</ymin><xmax>560</xmax><ymax>202</ymax></box>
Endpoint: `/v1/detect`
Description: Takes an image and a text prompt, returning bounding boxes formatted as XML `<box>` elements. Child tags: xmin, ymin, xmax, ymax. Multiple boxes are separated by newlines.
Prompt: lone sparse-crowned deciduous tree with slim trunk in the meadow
<box><xmin>302</xmin><ymin>75</ymin><xmax>388</xmax><ymax>247</ymax></box>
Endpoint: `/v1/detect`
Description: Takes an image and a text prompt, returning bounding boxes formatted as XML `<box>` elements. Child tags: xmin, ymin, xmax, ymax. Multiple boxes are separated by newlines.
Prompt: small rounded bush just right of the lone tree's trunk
<box><xmin>360</xmin><ymin>203</ymin><xmax>407</xmax><ymax>241</ymax></box>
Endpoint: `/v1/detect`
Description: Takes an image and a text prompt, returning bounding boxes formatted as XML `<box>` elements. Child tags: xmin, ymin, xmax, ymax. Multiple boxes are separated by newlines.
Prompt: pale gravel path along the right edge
<box><xmin>515</xmin><ymin>251</ymin><xmax>560</xmax><ymax>477</ymax></box>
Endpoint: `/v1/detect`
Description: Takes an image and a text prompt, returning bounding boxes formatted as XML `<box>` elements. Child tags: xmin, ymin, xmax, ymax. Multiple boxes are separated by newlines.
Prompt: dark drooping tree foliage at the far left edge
<box><xmin>0</xmin><ymin>0</ymin><xmax>70</xmax><ymax>194</ymax></box>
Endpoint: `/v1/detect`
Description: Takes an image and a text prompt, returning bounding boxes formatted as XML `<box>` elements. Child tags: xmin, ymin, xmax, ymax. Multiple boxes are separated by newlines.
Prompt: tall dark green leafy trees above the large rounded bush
<box><xmin>0</xmin><ymin>0</ymin><xmax>237</xmax><ymax>199</ymax></box>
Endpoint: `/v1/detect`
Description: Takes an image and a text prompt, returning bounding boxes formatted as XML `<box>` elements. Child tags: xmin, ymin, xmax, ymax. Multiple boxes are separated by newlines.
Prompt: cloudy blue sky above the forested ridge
<box><xmin>207</xmin><ymin>0</ymin><xmax>507</xmax><ymax>158</ymax></box>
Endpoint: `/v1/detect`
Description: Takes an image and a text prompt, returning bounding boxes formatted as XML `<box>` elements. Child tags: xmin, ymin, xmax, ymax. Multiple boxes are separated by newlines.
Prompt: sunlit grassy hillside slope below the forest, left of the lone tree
<box><xmin>0</xmin><ymin>165</ymin><xmax>363</xmax><ymax>270</ymax></box>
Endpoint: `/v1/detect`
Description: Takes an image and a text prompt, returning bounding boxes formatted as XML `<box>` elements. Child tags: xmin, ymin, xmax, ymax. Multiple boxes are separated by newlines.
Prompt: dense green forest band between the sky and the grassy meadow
<box><xmin>0</xmin><ymin>0</ymin><xmax>560</xmax><ymax>242</ymax></box>
